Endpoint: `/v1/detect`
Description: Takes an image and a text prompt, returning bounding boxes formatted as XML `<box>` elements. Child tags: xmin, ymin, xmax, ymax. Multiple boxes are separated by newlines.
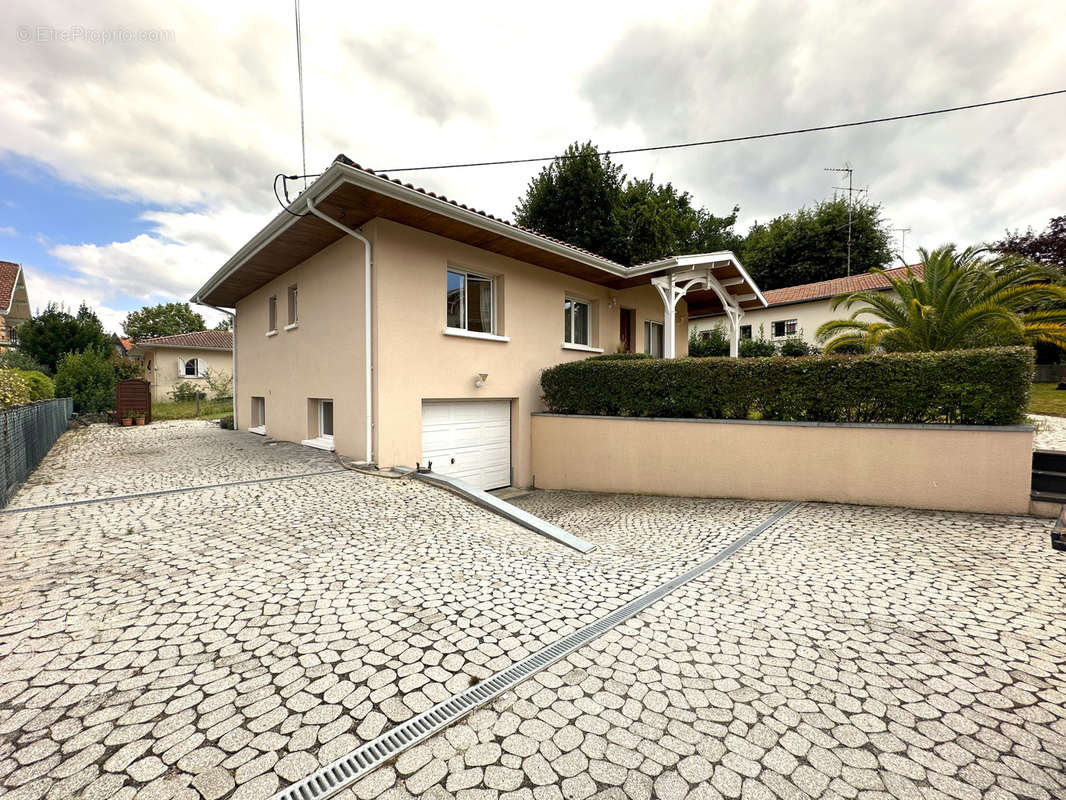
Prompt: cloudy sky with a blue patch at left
<box><xmin>0</xmin><ymin>0</ymin><xmax>1066</xmax><ymax>330</ymax></box>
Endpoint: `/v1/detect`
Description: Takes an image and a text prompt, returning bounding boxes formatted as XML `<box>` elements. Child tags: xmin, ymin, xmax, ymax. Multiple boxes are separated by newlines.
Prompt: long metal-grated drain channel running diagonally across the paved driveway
<box><xmin>271</xmin><ymin>501</ymin><xmax>800</xmax><ymax>800</ymax></box>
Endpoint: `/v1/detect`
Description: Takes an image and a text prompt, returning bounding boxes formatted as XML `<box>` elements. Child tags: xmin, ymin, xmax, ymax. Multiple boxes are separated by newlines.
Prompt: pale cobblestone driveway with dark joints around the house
<box><xmin>0</xmin><ymin>423</ymin><xmax>1066</xmax><ymax>800</ymax></box>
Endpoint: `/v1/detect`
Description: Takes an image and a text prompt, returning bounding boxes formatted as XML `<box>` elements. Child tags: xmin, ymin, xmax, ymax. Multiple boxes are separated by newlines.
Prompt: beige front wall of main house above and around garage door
<box><xmin>374</xmin><ymin>220</ymin><xmax>688</xmax><ymax>486</ymax></box>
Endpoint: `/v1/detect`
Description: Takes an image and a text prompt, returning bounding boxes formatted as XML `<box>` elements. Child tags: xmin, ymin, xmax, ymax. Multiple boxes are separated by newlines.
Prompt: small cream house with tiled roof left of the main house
<box><xmin>130</xmin><ymin>331</ymin><xmax>233</xmax><ymax>403</ymax></box>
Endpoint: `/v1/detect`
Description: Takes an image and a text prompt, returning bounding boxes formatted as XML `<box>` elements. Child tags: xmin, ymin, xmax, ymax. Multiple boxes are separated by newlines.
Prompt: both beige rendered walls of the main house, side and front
<box><xmin>236</xmin><ymin>219</ymin><xmax>688</xmax><ymax>485</ymax></box>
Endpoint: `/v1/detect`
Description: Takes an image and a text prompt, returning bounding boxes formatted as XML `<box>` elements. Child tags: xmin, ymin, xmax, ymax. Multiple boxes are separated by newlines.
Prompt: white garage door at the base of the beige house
<box><xmin>422</xmin><ymin>400</ymin><xmax>511</xmax><ymax>490</ymax></box>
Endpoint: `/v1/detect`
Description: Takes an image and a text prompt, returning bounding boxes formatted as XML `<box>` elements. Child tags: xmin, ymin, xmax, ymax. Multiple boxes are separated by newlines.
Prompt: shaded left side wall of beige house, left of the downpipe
<box><xmin>233</xmin><ymin>231</ymin><xmax>374</xmax><ymax>458</ymax></box>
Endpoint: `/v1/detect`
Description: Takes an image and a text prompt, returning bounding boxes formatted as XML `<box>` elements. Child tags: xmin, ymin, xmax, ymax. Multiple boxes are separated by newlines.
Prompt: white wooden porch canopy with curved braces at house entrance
<box><xmin>642</xmin><ymin>251</ymin><xmax>766</xmax><ymax>358</ymax></box>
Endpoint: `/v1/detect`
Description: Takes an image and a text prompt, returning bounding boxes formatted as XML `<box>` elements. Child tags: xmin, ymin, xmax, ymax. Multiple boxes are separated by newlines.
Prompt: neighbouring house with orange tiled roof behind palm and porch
<box><xmin>689</xmin><ymin>263</ymin><xmax>923</xmax><ymax>347</ymax></box>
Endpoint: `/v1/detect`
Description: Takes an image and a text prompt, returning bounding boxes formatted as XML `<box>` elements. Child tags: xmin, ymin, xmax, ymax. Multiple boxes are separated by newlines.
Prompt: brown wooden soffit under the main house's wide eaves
<box><xmin>204</xmin><ymin>183</ymin><xmax>622</xmax><ymax>307</ymax></box>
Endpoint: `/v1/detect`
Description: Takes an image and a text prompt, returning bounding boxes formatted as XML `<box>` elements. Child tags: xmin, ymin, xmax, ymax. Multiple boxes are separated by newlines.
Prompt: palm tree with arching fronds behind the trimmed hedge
<box><xmin>818</xmin><ymin>244</ymin><xmax>1066</xmax><ymax>353</ymax></box>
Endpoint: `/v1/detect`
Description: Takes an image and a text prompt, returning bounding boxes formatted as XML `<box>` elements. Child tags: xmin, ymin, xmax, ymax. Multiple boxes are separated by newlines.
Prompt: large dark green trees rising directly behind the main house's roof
<box><xmin>515</xmin><ymin>142</ymin><xmax>741</xmax><ymax>265</ymax></box>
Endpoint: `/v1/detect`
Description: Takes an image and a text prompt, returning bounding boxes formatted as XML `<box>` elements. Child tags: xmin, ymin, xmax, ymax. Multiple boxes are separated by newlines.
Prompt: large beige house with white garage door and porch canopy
<box><xmin>193</xmin><ymin>150</ymin><xmax>763</xmax><ymax>489</ymax></box>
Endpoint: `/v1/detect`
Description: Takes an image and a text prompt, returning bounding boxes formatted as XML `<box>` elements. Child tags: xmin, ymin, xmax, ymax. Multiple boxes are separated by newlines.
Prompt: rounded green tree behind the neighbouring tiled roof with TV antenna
<box><xmin>739</xmin><ymin>197</ymin><xmax>892</xmax><ymax>289</ymax></box>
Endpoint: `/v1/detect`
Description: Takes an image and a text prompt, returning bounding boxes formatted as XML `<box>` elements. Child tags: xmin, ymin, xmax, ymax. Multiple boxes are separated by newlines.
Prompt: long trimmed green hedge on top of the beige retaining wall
<box><xmin>540</xmin><ymin>347</ymin><xmax>1033</xmax><ymax>425</ymax></box>
